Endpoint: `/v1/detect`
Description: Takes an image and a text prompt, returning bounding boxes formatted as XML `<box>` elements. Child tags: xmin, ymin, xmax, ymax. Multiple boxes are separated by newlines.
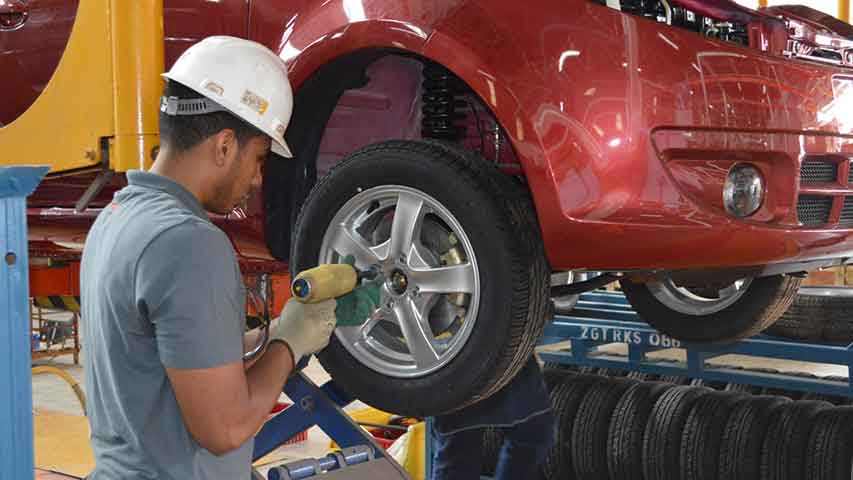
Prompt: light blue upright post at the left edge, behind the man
<box><xmin>0</xmin><ymin>167</ymin><xmax>48</xmax><ymax>478</ymax></box>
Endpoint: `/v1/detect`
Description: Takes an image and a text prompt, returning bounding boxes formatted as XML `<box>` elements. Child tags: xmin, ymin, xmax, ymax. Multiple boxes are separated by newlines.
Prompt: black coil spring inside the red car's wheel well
<box><xmin>421</xmin><ymin>65</ymin><xmax>466</xmax><ymax>141</ymax></box>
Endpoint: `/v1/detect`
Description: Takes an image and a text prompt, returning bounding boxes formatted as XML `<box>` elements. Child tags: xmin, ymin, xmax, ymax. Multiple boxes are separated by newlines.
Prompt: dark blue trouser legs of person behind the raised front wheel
<box><xmin>429</xmin><ymin>356</ymin><xmax>556</xmax><ymax>480</ymax></box>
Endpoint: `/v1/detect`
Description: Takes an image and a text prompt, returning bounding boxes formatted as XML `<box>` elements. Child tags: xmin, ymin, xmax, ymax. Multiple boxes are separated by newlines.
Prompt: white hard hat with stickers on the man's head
<box><xmin>160</xmin><ymin>36</ymin><xmax>293</xmax><ymax>158</ymax></box>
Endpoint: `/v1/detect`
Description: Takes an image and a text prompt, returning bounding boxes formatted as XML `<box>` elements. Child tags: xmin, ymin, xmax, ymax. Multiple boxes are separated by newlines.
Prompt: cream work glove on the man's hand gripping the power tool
<box><xmin>270</xmin><ymin>298</ymin><xmax>335</xmax><ymax>365</ymax></box>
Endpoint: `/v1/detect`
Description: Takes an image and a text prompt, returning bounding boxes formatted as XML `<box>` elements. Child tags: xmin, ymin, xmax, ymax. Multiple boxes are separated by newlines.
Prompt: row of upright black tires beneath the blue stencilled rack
<box><xmin>484</xmin><ymin>368</ymin><xmax>853</xmax><ymax>480</ymax></box>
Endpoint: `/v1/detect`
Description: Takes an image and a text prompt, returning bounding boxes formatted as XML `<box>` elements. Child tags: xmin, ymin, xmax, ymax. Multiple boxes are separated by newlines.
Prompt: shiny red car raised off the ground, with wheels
<box><xmin>5</xmin><ymin>0</ymin><xmax>853</xmax><ymax>414</ymax></box>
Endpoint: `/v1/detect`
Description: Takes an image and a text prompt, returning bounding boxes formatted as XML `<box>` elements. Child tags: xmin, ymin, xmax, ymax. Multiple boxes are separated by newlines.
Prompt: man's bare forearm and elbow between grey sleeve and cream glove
<box><xmin>166</xmin><ymin>342</ymin><xmax>293</xmax><ymax>455</ymax></box>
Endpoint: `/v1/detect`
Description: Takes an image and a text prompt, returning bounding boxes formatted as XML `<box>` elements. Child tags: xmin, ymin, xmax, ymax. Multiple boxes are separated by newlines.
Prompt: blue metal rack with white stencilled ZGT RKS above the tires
<box><xmin>539</xmin><ymin>292</ymin><xmax>853</xmax><ymax>397</ymax></box>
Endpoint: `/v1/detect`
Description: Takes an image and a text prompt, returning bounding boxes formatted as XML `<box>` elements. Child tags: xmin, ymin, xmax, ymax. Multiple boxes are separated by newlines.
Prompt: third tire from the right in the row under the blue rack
<box><xmin>719</xmin><ymin>396</ymin><xmax>789</xmax><ymax>480</ymax></box>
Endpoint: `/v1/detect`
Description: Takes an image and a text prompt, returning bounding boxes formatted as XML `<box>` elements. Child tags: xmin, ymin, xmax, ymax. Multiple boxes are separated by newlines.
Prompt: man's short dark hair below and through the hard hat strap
<box><xmin>160</xmin><ymin>80</ymin><xmax>265</xmax><ymax>153</ymax></box>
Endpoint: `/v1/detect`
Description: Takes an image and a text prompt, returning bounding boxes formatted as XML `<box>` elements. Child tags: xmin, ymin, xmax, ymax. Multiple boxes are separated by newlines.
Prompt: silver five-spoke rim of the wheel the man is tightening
<box><xmin>318</xmin><ymin>185</ymin><xmax>480</xmax><ymax>378</ymax></box>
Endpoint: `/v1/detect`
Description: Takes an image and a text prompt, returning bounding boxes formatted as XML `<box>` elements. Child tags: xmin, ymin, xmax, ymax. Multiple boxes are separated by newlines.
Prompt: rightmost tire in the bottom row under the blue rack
<box><xmin>805</xmin><ymin>407</ymin><xmax>853</xmax><ymax>480</ymax></box>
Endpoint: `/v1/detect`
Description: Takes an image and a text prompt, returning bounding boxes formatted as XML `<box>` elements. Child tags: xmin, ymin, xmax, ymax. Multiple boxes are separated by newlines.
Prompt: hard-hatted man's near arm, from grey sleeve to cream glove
<box><xmin>135</xmin><ymin>222</ymin><xmax>335</xmax><ymax>454</ymax></box>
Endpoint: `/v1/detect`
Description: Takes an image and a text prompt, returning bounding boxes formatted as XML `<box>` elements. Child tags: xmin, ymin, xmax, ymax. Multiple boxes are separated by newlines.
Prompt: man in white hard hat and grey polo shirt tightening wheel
<box><xmin>80</xmin><ymin>37</ymin><xmax>335</xmax><ymax>480</ymax></box>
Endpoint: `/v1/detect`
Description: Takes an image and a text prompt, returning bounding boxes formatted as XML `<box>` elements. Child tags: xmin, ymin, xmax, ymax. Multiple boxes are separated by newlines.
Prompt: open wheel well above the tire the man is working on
<box><xmin>264</xmin><ymin>50</ymin><xmax>523</xmax><ymax>260</ymax></box>
